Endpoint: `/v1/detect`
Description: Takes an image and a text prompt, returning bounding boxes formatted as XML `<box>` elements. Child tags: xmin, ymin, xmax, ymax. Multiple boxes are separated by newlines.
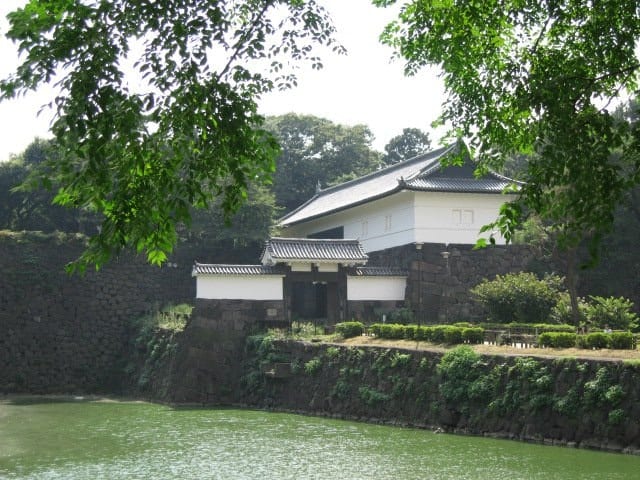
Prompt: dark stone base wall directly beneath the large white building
<box><xmin>368</xmin><ymin>243</ymin><xmax>534</xmax><ymax>323</ymax></box>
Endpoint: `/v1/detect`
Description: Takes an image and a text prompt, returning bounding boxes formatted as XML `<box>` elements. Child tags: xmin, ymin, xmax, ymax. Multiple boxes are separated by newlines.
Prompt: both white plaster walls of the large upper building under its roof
<box><xmin>285</xmin><ymin>191</ymin><xmax>509</xmax><ymax>252</ymax></box>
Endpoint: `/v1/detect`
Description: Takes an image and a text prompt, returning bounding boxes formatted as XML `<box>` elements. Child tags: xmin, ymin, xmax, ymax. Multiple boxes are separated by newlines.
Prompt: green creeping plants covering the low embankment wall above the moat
<box><xmin>244</xmin><ymin>334</ymin><xmax>639</xmax><ymax>440</ymax></box>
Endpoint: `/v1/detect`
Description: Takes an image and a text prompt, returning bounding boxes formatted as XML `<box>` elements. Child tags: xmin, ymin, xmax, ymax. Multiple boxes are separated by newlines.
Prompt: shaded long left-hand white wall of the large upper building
<box><xmin>283</xmin><ymin>192</ymin><xmax>414</xmax><ymax>252</ymax></box>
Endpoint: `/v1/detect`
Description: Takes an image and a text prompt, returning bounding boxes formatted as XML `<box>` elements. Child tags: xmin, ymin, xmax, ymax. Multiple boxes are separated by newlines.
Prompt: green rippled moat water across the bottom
<box><xmin>0</xmin><ymin>398</ymin><xmax>640</xmax><ymax>480</ymax></box>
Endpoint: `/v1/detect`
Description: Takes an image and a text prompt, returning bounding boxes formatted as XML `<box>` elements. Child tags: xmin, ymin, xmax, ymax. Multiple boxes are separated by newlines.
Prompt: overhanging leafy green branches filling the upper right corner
<box><xmin>374</xmin><ymin>0</ymin><xmax>640</xmax><ymax>254</ymax></box>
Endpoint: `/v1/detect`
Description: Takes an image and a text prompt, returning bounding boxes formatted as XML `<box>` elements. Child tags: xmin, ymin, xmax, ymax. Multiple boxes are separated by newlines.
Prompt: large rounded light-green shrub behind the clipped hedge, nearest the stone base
<box><xmin>471</xmin><ymin>272</ymin><xmax>562</xmax><ymax>323</ymax></box>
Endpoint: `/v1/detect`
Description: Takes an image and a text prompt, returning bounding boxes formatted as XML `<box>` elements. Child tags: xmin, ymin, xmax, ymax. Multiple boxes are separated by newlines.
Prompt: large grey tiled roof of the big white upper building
<box><xmin>279</xmin><ymin>142</ymin><xmax>518</xmax><ymax>226</ymax></box>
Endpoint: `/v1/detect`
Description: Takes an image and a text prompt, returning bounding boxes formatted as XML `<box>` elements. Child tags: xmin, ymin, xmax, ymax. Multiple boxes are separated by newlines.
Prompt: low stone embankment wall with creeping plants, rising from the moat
<box><xmin>242</xmin><ymin>341</ymin><xmax>640</xmax><ymax>454</ymax></box>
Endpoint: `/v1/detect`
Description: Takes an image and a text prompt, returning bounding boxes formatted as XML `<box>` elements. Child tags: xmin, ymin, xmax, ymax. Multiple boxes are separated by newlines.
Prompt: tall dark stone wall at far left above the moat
<box><xmin>0</xmin><ymin>232</ymin><xmax>202</xmax><ymax>393</ymax></box>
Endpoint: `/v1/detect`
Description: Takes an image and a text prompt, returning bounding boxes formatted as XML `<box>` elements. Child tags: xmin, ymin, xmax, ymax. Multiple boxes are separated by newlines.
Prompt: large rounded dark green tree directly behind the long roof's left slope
<box><xmin>265</xmin><ymin>113</ymin><xmax>380</xmax><ymax>211</ymax></box>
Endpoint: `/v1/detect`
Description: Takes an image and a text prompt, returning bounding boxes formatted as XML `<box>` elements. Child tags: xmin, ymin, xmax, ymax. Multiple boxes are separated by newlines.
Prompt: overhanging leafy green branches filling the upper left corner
<box><xmin>0</xmin><ymin>0</ymin><xmax>341</xmax><ymax>269</ymax></box>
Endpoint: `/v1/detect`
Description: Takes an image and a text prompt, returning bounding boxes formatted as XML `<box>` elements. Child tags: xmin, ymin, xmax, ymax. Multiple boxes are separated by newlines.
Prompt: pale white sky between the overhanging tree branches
<box><xmin>0</xmin><ymin>0</ymin><xmax>443</xmax><ymax>161</ymax></box>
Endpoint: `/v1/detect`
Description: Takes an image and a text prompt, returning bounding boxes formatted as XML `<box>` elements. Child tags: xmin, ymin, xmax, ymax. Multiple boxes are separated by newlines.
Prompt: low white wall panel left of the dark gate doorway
<box><xmin>196</xmin><ymin>275</ymin><xmax>284</xmax><ymax>300</ymax></box>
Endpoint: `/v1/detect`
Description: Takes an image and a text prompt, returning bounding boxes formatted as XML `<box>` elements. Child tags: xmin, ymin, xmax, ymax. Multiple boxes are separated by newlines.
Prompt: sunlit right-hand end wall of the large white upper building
<box><xmin>413</xmin><ymin>192</ymin><xmax>509</xmax><ymax>245</ymax></box>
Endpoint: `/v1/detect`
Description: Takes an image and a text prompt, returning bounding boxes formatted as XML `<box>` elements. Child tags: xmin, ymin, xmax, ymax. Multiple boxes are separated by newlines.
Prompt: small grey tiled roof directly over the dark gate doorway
<box><xmin>262</xmin><ymin>237</ymin><xmax>369</xmax><ymax>265</ymax></box>
